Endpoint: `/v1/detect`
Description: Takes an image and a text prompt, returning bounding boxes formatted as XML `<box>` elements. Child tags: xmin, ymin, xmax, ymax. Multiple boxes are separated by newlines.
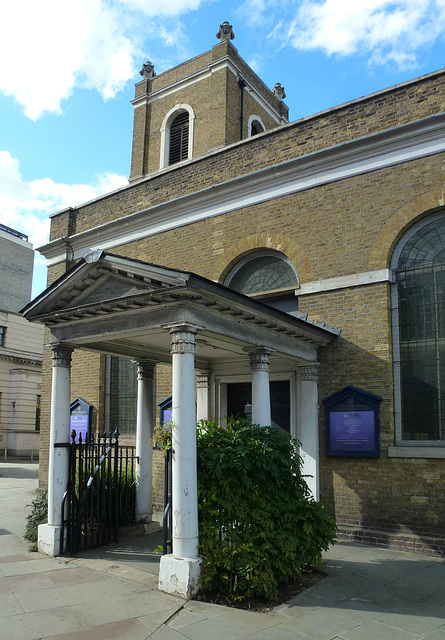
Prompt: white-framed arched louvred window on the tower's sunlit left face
<box><xmin>160</xmin><ymin>104</ymin><xmax>195</xmax><ymax>169</ymax></box>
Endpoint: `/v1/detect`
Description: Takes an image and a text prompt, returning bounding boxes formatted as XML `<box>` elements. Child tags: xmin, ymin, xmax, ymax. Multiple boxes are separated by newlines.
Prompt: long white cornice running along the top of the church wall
<box><xmin>38</xmin><ymin>114</ymin><xmax>445</xmax><ymax>265</ymax></box>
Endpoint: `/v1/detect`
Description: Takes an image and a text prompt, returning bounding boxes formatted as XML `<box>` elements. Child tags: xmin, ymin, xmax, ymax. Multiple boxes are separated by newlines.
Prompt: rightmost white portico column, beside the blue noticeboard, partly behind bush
<box><xmin>297</xmin><ymin>363</ymin><xmax>320</xmax><ymax>500</ymax></box>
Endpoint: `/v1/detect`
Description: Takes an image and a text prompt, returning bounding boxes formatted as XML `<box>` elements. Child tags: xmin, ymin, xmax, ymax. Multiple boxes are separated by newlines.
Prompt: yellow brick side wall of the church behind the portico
<box><xmin>41</xmin><ymin>63</ymin><xmax>445</xmax><ymax>552</ymax></box>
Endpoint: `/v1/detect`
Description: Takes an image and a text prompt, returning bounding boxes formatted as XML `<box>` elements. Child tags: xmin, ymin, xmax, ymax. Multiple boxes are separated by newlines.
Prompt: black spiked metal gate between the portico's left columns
<box><xmin>59</xmin><ymin>429</ymin><xmax>136</xmax><ymax>555</ymax></box>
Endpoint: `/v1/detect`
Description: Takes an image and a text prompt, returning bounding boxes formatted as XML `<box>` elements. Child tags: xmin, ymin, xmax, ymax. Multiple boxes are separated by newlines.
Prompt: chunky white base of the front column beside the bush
<box><xmin>158</xmin><ymin>554</ymin><xmax>201</xmax><ymax>599</ymax></box>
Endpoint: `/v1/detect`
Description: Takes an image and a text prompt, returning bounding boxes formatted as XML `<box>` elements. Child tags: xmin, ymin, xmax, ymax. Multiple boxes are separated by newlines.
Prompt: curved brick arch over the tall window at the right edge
<box><xmin>368</xmin><ymin>191</ymin><xmax>445</xmax><ymax>271</ymax></box>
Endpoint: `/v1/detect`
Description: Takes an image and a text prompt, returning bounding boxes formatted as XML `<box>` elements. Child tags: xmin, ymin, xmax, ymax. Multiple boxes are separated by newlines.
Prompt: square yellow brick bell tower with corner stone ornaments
<box><xmin>130</xmin><ymin>22</ymin><xmax>289</xmax><ymax>182</ymax></box>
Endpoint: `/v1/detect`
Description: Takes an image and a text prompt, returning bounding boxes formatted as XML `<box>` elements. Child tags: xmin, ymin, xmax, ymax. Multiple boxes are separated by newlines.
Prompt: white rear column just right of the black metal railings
<box><xmin>136</xmin><ymin>360</ymin><xmax>155</xmax><ymax>522</ymax></box>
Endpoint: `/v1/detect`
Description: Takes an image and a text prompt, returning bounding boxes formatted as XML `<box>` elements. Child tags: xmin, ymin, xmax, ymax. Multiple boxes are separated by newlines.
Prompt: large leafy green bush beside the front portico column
<box><xmin>198</xmin><ymin>420</ymin><xmax>336</xmax><ymax>600</ymax></box>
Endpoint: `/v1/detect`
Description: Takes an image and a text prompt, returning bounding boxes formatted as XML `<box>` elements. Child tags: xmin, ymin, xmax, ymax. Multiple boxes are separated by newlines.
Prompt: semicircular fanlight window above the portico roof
<box><xmin>224</xmin><ymin>251</ymin><xmax>298</xmax><ymax>295</ymax></box>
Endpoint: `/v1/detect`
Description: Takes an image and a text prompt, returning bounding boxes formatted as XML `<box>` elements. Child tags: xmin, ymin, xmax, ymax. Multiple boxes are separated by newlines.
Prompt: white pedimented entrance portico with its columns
<box><xmin>24</xmin><ymin>251</ymin><xmax>337</xmax><ymax>597</ymax></box>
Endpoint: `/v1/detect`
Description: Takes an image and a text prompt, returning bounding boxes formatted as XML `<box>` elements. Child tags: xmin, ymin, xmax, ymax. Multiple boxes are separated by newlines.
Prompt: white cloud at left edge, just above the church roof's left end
<box><xmin>0</xmin><ymin>151</ymin><xmax>128</xmax><ymax>246</ymax></box>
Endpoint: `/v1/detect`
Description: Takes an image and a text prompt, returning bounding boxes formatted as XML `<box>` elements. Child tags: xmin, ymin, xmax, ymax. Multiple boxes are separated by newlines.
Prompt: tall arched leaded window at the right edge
<box><xmin>391</xmin><ymin>212</ymin><xmax>445</xmax><ymax>445</ymax></box>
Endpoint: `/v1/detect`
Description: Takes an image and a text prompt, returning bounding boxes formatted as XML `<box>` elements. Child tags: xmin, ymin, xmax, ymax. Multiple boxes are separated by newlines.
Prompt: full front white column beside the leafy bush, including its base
<box><xmin>159</xmin><ymin>324</ymin><xmax>199</xmax><ymax>598</ymax></box>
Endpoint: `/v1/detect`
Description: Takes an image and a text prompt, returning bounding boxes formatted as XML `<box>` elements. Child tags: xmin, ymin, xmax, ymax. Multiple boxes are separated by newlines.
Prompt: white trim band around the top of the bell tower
<box><xmin>131</xmin><ymin>56</ymin><xmax>289</xmax><ymax>125</ymax></box>
